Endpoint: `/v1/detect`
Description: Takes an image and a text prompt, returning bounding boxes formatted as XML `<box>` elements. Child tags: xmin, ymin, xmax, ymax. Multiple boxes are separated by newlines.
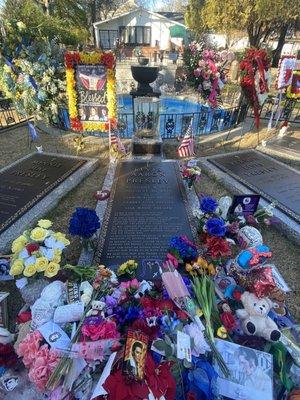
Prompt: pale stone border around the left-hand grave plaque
<box><xmin>0</xmin><ymin>152</ymin><xmax>99</xmax><ymax>252</ymax></box>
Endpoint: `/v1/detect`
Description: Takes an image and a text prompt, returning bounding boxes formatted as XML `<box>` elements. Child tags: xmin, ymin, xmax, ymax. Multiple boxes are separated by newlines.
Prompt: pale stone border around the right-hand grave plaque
<box><xmin>198</xmin><ymin>149</ymin><xmax>300</xmax><ymax>244</ymax></box>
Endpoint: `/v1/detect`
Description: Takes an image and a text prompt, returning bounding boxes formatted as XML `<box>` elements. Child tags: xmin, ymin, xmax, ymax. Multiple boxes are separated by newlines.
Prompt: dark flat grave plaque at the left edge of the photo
<box><xmin>0</xmin><ymin>153</ymin><xmax>86</xmax><ymax>233</ymax></box>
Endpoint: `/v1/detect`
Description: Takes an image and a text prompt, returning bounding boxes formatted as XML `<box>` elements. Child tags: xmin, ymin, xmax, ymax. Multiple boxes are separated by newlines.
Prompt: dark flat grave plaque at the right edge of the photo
<box><xmin>208</xmin><ymin>150</ymin><xmax>300</xmax><ymax>222</ymax></box>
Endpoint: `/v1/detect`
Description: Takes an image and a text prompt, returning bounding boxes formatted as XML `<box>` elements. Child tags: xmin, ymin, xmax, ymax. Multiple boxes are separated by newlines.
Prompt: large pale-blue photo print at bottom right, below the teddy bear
<box><xmin>215</xmin><ymin>339</ymin><xmax>273</xmax><ymax>400</ymax></box>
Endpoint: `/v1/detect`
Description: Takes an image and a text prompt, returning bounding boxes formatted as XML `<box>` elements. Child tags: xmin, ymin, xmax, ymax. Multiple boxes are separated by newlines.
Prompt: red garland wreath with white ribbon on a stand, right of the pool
<box><xmin>240</xmin><ymin>48</ymin><xmax>269</xmax><ymax>128</ymax></box>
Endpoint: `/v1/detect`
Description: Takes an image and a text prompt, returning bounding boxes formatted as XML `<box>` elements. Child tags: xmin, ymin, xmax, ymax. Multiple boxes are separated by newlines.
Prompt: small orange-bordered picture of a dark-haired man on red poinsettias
<box><xmin>122</xmin><ymin>330</ymin><xmax>148</xmax><ymax>380</ymax></box>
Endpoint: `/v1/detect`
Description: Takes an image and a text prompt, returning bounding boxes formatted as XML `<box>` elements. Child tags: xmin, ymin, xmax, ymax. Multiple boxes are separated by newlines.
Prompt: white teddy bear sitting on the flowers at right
<box><xmin>236</xmin><ymin>292</ymin><xmax>281</xmax><ymax>342</ymax></box>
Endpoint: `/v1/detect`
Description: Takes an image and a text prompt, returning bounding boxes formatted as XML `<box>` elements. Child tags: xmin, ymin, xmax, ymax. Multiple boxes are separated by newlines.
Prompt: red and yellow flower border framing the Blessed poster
<box><xmin>65</xmin><ymin>51</ymin><xmax>117</xmax><ymax>132</ymax></box>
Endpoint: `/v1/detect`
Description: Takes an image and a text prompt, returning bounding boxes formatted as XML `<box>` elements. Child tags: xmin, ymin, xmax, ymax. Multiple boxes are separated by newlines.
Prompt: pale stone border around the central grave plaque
<box><xmin>78</xmin><ymin>155</ymin><xmax>199</xmax><ymax>266</ymax></box>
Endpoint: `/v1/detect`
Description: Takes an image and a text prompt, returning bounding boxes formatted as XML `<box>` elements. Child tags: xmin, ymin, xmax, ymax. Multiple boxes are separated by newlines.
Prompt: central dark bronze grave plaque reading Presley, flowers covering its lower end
<box><xmin>94</xmin><ymin>161</ymin><xmax>193</xmax><ymax>279</ymax></box>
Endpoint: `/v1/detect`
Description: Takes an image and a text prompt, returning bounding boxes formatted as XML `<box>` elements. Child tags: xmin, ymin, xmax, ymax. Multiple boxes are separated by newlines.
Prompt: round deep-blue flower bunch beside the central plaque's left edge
<box><xmin>69</xmin><ymin>208</ymin><xmax>100</xmax><ymax>238</ymax></box>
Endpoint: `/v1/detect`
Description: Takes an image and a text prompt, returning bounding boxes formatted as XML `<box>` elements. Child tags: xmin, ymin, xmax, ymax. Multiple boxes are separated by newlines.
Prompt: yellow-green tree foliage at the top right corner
<box><xmin>186</xmin><ymin>0</ymin><xmax>299</xmax><ymax>63</ymax></box>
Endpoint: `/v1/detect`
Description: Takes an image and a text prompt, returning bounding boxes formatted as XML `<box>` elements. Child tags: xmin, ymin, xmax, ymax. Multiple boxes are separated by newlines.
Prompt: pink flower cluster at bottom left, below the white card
<box><xmin>28</xmin><ymin>344</ymin><xmax>59</xmax><ymax>391</ymax></box>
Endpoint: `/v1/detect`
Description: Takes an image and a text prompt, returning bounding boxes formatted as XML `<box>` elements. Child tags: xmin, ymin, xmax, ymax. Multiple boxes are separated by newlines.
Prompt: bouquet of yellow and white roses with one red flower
<box><xmin>10</xmin><ymin>219</ymin><xmax>70</xmax><ymax>278</ymax></box>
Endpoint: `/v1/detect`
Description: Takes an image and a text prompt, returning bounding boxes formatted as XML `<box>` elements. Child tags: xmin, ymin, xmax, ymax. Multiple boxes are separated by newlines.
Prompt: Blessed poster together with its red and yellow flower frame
<box><xmin>65</xmin><ymin>51</ymin><xmax>117</xmax><ymax>132</ymax></box>
